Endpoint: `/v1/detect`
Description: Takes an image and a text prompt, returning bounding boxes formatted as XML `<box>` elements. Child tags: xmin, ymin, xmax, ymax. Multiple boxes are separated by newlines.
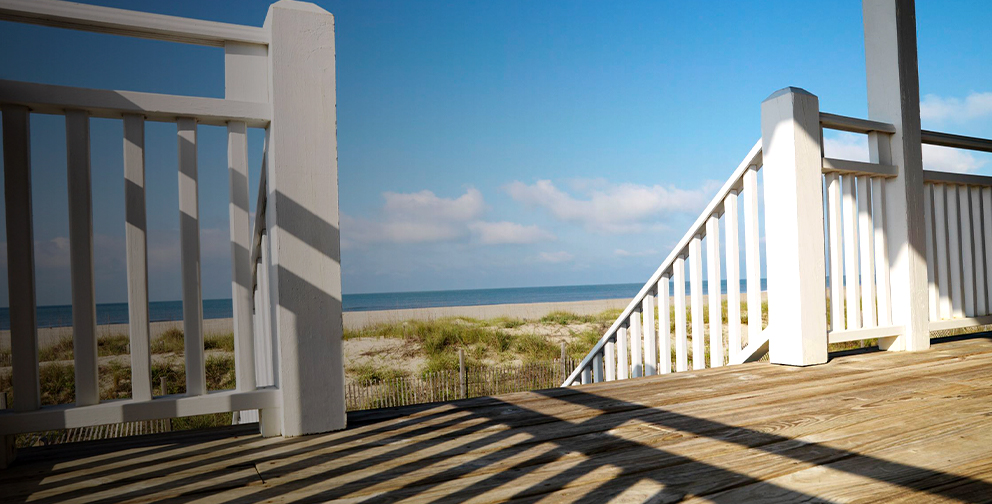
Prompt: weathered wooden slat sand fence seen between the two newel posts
<box><xmin>345</xmin><ymin>359</ymin><xmax>576</xmax><ymax>411</ymax></box>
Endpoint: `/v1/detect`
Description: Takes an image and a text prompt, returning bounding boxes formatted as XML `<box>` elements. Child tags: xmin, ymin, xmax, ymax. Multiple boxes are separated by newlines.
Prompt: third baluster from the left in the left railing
<box><xmin>124</xmin><ymin>114</ymin><xmax>152</xmax><ymax>401</ymax></box>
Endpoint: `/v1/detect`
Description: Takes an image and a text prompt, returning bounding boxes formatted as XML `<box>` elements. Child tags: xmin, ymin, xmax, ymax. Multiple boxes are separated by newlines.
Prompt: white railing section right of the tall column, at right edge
<box><xmin>922</xmin><ymin>131</ymin><xmax>992</xmax><ymax>331</ymax></box>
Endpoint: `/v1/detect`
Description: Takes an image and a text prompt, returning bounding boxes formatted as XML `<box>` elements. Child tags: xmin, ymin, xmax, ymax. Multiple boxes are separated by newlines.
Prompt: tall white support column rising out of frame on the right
<box><xmin>862</xmin><ymin>0</ymin><xmax>930</xmax><ymax>350</ymax></box>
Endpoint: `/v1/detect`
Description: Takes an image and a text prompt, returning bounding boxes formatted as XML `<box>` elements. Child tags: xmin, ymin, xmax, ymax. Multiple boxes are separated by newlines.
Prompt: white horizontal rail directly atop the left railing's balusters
<box><xmin>0</xmin><ymin>80</ymin><xmax>270</xmax><ymax>128</ymax></box>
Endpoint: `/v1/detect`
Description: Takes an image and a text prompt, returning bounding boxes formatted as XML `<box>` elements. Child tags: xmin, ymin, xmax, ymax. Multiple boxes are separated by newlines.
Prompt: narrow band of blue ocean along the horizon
<box><xmin>0</xmin><ymin>279</ymin><xmax>766</xmax><ymax>330</ymax></box>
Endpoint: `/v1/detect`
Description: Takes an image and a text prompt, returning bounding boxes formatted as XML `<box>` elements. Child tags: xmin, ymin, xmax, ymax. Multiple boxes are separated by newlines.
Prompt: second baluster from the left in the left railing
<box><xmin>65</xmin><ymin>110</ymin><xmax>100</xmax><ymax>406</ymax></box>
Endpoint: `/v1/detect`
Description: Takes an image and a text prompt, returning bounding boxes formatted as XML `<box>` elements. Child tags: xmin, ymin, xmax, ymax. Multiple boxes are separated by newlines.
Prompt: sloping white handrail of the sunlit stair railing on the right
<box><xmin>564</xmin><ymin>139</ymin><xmax>761</xmax><ymax>385</ymax></box>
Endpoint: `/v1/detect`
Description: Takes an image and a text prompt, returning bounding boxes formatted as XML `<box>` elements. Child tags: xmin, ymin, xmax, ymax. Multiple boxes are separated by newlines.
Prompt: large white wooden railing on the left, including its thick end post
<box><xmin>0</xmin><ymin>0</ymin><xmax>344</xmax><ymax>465</ymax></box>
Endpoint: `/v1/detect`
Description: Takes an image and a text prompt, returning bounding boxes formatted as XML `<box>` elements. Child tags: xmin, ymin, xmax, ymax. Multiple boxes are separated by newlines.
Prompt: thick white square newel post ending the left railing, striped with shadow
<box><xmin>265</xmin><ymin>0</ymin><xmax>345</xmax><ymax>436</ymax></box>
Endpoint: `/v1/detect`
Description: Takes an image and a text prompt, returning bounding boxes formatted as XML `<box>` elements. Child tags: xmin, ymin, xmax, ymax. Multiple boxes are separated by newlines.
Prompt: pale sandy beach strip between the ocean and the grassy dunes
<box><xmin>0</xmin><ymin>292</ymin><xmax>767</xmax><ymax>349</ymax></box>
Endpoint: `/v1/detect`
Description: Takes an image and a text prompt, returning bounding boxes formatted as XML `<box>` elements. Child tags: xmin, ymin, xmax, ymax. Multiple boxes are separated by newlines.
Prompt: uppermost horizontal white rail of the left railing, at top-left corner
<box><xmin>0</xmin><ymin>0</ymin><xmax>269</xmax><ymax>47</ymax></box>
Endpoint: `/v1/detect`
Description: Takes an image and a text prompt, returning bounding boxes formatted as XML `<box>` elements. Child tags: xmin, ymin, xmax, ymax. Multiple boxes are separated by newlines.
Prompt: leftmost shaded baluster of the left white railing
<box><xmin>0</xmin><ymin>104</ymin><xmax>41</xmax><ymax>412</ymax></box>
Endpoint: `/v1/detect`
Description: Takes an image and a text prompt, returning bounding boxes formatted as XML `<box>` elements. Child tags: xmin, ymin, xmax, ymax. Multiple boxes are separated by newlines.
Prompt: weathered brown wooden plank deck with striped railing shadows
<box><xmin>0</xmin><ymin>335</ymin><xmax>992</xmax><ymax>503</ymax></box>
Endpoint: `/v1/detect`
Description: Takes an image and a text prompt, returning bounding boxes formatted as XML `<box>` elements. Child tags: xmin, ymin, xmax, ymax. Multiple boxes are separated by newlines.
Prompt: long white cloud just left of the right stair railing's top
<box><xmin>506</xmin><ymin>180</ymin><xmax>711</xmax><ymax>233</ymax></box>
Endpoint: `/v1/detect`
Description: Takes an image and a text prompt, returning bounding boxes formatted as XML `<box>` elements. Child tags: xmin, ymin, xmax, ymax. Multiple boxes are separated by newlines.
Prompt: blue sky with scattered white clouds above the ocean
<box><xmin>0</xmin><ymin>0</ymin><xmax>992</xmax><ymax>306</ymax></box>
